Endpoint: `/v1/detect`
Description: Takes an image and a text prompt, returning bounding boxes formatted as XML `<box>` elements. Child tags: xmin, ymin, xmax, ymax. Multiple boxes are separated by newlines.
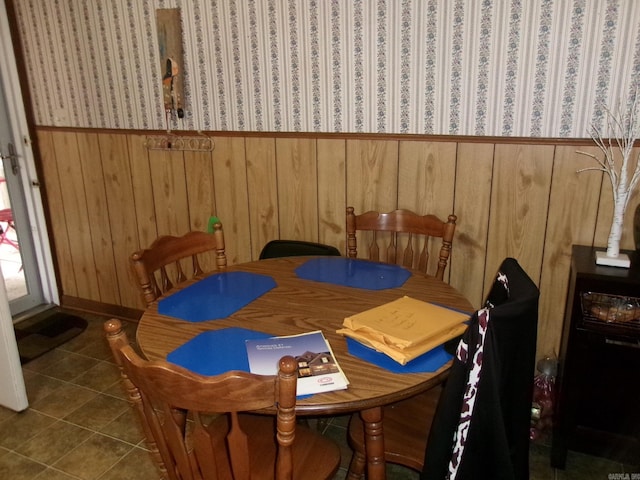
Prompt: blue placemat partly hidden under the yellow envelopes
<box><xmin>346</xmin><ymin>337</ymin><xmax>453</xmax><ymax>373</ymax></box>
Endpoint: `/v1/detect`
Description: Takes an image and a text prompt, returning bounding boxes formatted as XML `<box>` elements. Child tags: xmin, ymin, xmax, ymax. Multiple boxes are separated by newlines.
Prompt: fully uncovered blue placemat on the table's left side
<box><xmin>158</xmin><ymin>272</ymin><xmax>276</xmax><ymax>322</ymax></box>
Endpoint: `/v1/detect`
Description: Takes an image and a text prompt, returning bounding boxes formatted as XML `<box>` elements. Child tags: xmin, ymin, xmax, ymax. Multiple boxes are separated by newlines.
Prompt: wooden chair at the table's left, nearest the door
<box><xmin>130</xmin><ymin>223</ymin><xmax>227</xmax><ymax>306</ymax></box>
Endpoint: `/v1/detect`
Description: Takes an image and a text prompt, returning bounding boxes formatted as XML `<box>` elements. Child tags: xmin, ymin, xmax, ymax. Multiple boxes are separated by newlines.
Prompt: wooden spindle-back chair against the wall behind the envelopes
<box><xmin>347</xmin><ymin>207</ymin><xmax>457</xmax><ymax>280</ymax></box>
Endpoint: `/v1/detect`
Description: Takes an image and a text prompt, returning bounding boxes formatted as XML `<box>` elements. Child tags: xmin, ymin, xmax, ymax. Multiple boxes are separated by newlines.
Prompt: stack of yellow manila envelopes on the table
<box><xmin>337</xmin><ymin>296</ymin><xmax>469</xmax><ymax>365</ymax></box>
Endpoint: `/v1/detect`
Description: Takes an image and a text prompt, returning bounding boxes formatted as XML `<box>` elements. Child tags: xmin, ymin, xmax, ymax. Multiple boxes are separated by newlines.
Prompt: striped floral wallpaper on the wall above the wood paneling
<box><xmin>13</xmin><ymin>0</ymin><xmax>640</xmax><ymax>138</ymax></box>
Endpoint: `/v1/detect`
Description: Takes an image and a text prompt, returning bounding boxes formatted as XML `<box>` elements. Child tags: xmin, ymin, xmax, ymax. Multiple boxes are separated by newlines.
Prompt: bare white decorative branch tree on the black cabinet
<box><xmin>577</xmin><ymin>88</ymin><xmax>640</xmax><ymax>258</ymax></box>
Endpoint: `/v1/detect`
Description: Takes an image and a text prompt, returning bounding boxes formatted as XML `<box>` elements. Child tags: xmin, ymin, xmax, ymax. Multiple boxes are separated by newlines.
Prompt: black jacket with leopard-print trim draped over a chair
<box><xmin>420</xmin><ymin>258</ymin><xmax>539</xmax><ymax>480</ymax></box>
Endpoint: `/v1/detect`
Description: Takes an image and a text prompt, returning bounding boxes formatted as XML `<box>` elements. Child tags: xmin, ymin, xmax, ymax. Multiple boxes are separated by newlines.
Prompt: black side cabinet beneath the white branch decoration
<box><xmin>551</xmin><ymin>246</ymin><xmax>640</xmax><ymax>468</ymax></box>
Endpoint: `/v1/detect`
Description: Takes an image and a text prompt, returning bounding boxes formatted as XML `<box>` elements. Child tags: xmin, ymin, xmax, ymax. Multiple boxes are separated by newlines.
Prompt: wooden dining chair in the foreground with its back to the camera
<box><xmin>104</xmin><ymin>319</ymin><xmax>340</xmax><ymax>480</ymax></box>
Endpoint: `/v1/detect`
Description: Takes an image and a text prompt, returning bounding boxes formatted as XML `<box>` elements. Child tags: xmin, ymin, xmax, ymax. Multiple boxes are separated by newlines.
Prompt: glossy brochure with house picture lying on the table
<box><xmin>245</xmin><ymin>330</ymin><xmax>349</xmax><ymax>395</ymax></box>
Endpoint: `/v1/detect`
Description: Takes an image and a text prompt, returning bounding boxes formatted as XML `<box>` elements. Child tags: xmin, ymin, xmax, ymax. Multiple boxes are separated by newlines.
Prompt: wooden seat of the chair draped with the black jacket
<box><xmin>348</xmin><ymin>386</ymin><xmax>442</xmax><ymax>471</ymax></box>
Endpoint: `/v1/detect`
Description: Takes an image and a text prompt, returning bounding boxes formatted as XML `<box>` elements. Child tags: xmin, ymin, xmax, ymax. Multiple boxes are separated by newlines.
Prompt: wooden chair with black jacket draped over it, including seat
<box><xmin>347</xmin><ymin>258</ymin><xmax>539</xmax><ymax>480</ymax></box>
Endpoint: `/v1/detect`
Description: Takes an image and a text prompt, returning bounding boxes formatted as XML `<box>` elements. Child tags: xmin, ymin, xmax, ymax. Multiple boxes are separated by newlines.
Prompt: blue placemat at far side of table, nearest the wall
<box><xmin>295</xmin><ymin>257</ymin><xmax>411</xmax><ymax>290</ymax></box>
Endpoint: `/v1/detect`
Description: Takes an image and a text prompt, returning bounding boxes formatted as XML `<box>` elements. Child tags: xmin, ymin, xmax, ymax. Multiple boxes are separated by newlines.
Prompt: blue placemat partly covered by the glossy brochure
<box><xmin>167</xmin><ymin>327</ymin><xmax>272</xmax><ymax>375</ymax></box>
